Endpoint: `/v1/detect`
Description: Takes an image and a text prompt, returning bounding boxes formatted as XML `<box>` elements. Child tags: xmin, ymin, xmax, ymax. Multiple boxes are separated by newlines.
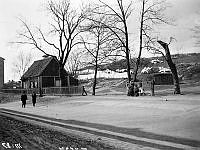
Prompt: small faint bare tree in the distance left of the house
<box><xmin>12</xmin><ymin>51</ymin><xmax>33</xmax><ymax>78</ymax></box>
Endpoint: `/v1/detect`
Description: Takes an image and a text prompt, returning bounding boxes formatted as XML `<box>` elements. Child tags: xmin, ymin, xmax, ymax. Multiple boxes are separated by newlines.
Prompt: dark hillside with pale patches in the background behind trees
<box><xmin>82</xmin><ymin>53</ymin><xmax>200</xmax><ymax>81</ymax></box>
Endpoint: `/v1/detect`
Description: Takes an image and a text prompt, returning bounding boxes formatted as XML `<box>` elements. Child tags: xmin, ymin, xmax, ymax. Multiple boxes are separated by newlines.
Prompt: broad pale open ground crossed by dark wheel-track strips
<box><xmin>0</xmin><ymin>95</ymin><xmax>200</xmax><ymax>149</ymax></box>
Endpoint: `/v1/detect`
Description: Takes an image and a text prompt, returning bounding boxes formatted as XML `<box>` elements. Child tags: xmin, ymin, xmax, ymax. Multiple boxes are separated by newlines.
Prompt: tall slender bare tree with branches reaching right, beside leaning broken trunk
<box><xmin>133</xmin><ymin>0</ymin><xmax>170</xmax><ymax>81</ymax></box>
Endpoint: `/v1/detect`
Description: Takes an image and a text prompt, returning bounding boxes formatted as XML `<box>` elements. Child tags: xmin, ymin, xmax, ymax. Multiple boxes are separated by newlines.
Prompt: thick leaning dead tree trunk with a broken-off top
<box><xmin>158</xmin><ymin>41</ymin><xmax>181</xmax><ymax>94</ymax></box>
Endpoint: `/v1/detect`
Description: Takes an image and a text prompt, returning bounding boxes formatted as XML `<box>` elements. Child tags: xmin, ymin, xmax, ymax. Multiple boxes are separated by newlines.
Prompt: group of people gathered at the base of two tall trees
<box><xmin>127</xmin><ymin>82</ymin><xmax>144</xmax><ymax>96</ymax></box>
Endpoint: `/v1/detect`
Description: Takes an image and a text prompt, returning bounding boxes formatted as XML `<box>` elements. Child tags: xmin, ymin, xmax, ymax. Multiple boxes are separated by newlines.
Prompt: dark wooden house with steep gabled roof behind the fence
<box><xmin>21</xmin><ymin>57</ymin><xmax>78</xmax><ymax>89</ymax></box>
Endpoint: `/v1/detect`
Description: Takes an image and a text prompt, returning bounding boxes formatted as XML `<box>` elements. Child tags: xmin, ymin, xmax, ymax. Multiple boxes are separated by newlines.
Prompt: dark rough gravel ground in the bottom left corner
<box><xmin>0</xmin><ymin>116</ymin><xmax>119</xmax><ymax>150</ymax></box>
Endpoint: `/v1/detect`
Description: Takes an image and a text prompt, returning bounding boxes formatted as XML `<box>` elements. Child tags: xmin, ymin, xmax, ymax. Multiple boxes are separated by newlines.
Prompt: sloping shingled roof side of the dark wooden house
<box><xmin>21</xmin><ymin>57</ymin><xmax>55</xmax><ymax>79</ymax></box>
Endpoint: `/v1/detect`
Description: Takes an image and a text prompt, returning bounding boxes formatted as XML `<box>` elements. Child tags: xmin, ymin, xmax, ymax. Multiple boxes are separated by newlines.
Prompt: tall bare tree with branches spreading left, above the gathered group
<box><xmin>89</xmin><ymin>0</ymin><xmax>132</xmax><ymax>81</ymax></box>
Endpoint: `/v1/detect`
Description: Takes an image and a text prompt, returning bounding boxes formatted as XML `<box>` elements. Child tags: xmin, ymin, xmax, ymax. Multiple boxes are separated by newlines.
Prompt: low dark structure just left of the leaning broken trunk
<box><xmin>153</xmin><ymin>73</ymin><xmax>174</xmax><ymax>85</ymax></box>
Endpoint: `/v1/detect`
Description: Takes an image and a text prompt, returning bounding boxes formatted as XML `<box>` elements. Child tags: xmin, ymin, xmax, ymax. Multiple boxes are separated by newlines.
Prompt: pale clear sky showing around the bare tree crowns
<box><xmin>0</xmin><ymin>0</ymin><xmax>200</xmax><ymax>82</ymax></box>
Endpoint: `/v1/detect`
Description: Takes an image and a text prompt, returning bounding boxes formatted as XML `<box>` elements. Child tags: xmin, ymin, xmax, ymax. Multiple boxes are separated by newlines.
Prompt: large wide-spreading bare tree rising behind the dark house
<box><xmin>15</xmin><ymin>0</ymin><xmax>86</xmax><ymax>85</ymax></box>
